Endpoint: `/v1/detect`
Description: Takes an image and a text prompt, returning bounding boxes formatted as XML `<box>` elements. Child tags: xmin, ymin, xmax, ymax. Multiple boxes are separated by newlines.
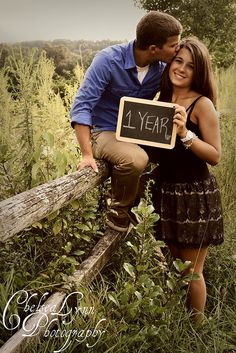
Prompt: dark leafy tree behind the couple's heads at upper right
<box><xmin>134</xmin><ymin>0</ymin><xmax>236</xmax><ymax>67</ymax></box>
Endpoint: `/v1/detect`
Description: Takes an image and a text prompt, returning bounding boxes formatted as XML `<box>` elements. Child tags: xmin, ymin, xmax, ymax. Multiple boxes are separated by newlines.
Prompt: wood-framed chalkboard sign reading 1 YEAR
<box><xmin>116</xmin><ymin>97</ymin><xmax>176</xmax><ymax>149</ymax></box>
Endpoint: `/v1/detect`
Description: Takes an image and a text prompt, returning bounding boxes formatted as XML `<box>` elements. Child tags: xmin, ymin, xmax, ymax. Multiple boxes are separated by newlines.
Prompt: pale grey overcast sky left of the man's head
<box><xmin>0</xmin><ymin>0</ymin><xmax>145</xmax><ymax>43</ymax></box>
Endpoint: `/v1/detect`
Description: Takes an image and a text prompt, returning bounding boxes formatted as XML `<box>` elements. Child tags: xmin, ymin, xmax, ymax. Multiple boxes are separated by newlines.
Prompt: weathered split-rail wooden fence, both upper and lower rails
<box><xmin>0</xmin><ymin>161</ymin><xmax>129</xmax><ymax>353</ymax></box>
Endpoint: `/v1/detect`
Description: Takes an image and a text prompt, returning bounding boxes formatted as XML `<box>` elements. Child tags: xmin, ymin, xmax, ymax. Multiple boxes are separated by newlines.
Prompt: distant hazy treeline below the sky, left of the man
<box><xmin>0</xmin><ymin>39</ymin><xmax>122</xmax><ymax>79</ymax></box>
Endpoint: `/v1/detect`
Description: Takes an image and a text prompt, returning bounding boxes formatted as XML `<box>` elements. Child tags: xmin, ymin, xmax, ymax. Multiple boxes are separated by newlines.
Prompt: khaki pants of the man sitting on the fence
<box><xmin>92</xmin><ymin>131</ymin><xmax>149</xmax><ymax>214</ymax></box>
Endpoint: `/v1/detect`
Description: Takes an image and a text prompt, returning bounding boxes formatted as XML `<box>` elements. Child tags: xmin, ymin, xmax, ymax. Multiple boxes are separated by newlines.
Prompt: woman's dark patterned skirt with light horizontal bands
<box><xmin>154</xmin><ymin>175</ymin><xmax>224</xmax><ymax>248</ymax></box>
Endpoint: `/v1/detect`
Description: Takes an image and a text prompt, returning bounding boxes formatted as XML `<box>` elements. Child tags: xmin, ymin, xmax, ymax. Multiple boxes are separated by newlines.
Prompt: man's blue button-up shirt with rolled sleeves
<box><xmin>70</xmin><ymin>41</ymin><xmax>165</xmax><ymax>131</ymax></box>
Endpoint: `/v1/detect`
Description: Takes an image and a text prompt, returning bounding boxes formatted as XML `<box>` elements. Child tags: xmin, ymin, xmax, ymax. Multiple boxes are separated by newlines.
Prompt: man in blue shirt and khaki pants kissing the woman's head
<box><xmin>71</xmin><ymin>11</ymin><xmax>182</xmax><ymax>232</ymax></box>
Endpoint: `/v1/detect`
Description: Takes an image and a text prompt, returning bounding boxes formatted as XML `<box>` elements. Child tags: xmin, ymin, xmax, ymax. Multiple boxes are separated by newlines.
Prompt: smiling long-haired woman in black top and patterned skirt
<box><xmin>156</xmin><ymin>38</ymin><xmax>223</xmax><ymax>320</ymax></box>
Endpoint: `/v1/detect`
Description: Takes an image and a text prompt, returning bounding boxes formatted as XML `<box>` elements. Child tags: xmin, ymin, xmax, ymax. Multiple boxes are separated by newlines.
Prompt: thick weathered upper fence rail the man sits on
<box><xmin>0</xmin><ymin>161</ymin><xmax>109</xmax><ymax>241</ymax></box>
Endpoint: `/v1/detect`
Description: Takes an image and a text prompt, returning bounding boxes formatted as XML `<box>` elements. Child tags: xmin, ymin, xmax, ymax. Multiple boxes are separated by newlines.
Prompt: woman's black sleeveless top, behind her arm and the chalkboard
<box><xmin>158</xmin><ymin>96</ymin><xmax>209</xmax><ymax>183</ymax></box>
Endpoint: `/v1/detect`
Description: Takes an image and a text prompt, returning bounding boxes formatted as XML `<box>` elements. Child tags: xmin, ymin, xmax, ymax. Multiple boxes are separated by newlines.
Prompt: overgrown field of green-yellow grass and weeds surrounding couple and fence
<box><xmin>0</xmin><ymin>52</ymin><xmax>236</xmax><ymax>353</ymax></box>
